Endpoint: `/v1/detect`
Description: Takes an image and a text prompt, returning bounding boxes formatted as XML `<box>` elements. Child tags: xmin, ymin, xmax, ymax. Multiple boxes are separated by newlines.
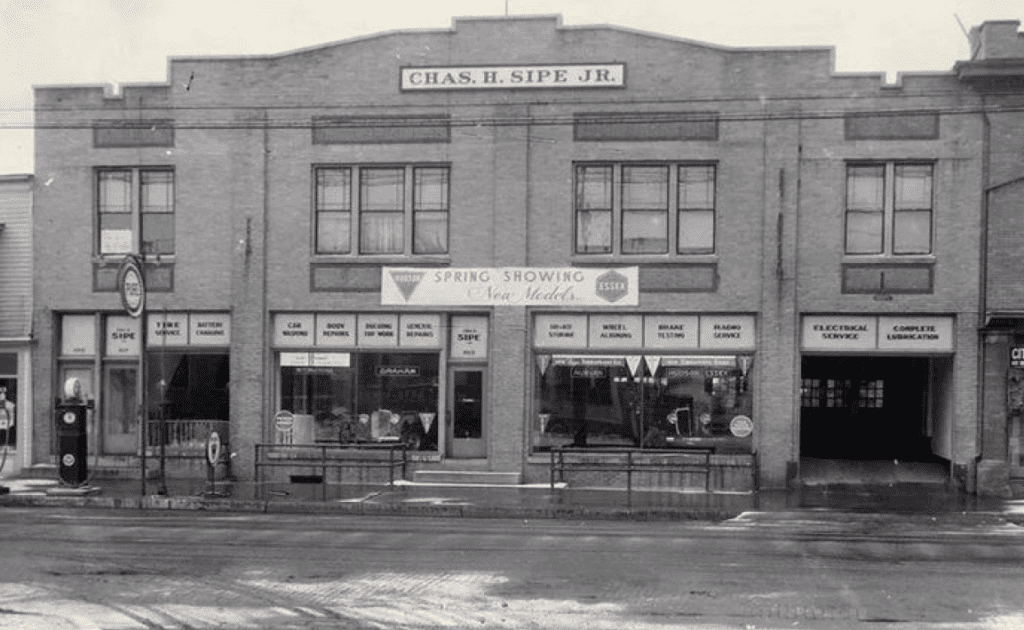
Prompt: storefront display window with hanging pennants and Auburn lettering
<box><xmin>534</xmin><ymin>361</ymin><xmax>752</xmax><ymax>451</ymax></box>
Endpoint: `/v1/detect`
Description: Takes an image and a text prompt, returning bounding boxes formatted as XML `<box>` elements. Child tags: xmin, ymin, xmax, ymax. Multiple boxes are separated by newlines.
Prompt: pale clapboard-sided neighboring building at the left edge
<box><xmin>0</xmin><ymin>174</ymin><xmax>33</xmax><ymax>476</ymax></box>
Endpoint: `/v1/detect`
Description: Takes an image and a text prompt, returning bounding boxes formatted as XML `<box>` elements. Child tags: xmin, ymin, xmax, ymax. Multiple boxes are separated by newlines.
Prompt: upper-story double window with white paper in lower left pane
<box><xmin>96</xmin><ymin>168</ymin><xmax>174</xmax><ymax>255</ymax></box>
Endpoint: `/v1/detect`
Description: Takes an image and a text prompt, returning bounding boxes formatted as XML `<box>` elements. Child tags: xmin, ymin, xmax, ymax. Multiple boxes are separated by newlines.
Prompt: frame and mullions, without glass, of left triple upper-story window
<box><xmin>310</xmin><ymin>162</ymin><xmax>452</xmax><ymax>260</ymax></box>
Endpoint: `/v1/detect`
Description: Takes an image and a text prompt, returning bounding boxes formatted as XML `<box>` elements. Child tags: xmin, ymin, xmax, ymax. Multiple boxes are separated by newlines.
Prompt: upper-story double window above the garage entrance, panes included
<box><xmin>846</xmin><ymin>162</ymin><xmax>933</xmax><ymax>255</ymax></box>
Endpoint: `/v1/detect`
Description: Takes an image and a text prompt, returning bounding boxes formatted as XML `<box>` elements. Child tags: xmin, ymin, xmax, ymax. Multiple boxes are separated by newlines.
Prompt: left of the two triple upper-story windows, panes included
<box><xmin>313</xmin><ymin>166</ymin><xmax>450</xmax><ymax>255</ymax></box>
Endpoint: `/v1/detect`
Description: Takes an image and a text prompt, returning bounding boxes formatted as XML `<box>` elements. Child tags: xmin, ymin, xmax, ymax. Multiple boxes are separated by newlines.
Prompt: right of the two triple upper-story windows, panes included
<box><xmin>574</xmin><ymin>164</ymin><xmax>716</xmax><ymax>255</ymax></box>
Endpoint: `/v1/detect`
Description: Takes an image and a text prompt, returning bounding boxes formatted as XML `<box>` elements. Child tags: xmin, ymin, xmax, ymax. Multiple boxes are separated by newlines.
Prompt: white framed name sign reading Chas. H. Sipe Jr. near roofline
<box><xmin>401</xmin><ymin>64</ymin><xmax>626</xmax><ymax>91</ymax></box>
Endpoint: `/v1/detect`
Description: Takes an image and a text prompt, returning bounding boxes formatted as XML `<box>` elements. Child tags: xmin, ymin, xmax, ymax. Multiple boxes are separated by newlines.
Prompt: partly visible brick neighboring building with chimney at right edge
<box><xmin>954</xmin><ymin>20</ymin><xmax>1024</xmax><ymax>494</ymax></box>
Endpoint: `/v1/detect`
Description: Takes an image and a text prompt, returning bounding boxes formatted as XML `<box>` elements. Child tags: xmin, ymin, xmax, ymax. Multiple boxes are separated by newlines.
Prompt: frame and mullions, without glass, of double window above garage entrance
<box><xmin>843</xmin><ymin>160</ymin><xmax>936</xmax><ymax>259</ymax></box>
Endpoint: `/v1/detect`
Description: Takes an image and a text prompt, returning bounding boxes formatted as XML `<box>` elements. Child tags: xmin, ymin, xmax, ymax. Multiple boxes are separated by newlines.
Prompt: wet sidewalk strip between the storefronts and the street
<box><xmin>0</xmin><ymin>478</ymin><xmax>1024</xmax><ymax>526</ymax></box>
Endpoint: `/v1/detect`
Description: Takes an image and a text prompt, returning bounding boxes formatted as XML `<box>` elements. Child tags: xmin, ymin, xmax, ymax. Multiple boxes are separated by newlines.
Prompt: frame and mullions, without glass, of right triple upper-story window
<box><xmin>570</xmin><ymin>160</ymin><xmax>719</xmax><ymax>260</ymax></box>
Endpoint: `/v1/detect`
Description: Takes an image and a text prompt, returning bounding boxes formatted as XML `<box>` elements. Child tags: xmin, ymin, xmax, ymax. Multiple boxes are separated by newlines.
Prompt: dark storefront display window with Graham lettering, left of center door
<box><xmin>281</xmin><ymin>352</ymin><xmax>438</xmax><ymax>451</ymax></box>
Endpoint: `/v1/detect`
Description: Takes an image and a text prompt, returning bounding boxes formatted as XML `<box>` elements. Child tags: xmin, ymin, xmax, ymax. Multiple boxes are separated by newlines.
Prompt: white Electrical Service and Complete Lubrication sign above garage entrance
<box><xmin>802</xmin><ymin>316</ymin><xmax>953</xmax><ymax>352</ymax></box>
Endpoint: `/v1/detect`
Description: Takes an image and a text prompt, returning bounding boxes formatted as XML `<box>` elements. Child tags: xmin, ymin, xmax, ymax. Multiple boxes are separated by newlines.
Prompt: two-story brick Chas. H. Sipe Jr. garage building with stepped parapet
<box><xmin>32</xmin><ymin>16</ymin><xmax>983</xmax><ymax>490</ymax></box>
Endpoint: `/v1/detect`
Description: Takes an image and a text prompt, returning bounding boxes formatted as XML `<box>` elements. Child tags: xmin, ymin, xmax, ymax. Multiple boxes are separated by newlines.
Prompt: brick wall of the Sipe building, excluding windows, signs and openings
<box><xmin>33</xmin><ymin>17</ymin><xmax>999</xmax><ymax>488</ymax></box>
